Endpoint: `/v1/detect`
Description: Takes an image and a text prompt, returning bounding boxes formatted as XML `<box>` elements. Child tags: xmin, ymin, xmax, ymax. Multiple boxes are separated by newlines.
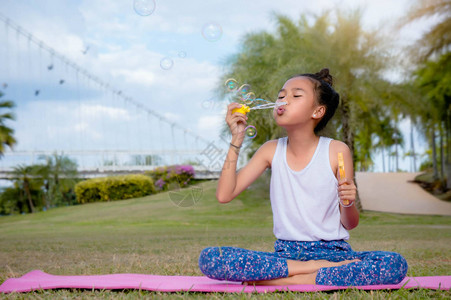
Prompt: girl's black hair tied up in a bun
<box><xmin>291</xmin><ymin>68</ymin><xmax>340</xmax><ymax>134</ymax></box>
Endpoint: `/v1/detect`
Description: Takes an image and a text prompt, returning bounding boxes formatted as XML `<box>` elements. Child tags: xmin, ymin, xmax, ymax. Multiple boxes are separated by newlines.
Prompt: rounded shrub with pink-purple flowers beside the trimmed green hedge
<box><xmin>146</xmin><ymin>165</ymin><xmax>194</xmax><ymax>190</ymax></box>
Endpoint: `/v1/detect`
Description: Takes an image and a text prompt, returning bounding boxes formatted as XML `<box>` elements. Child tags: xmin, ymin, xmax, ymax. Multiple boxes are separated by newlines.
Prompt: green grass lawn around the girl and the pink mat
<box><xmin>0</xmin><ymin>178</ymin><xmax>451</xmax><ymax>299</ymax></box>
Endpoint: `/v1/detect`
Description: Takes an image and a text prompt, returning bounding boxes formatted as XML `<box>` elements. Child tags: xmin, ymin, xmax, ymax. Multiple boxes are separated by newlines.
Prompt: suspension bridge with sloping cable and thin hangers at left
<box><xmin>0</xmin><ymin>14</ymin><xmax>240</xmax><ymax>179</ymax></box>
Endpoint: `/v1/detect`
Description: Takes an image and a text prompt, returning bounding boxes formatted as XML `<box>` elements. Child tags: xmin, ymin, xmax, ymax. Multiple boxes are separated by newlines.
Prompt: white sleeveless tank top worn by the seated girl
<box><xmin>270</xmin><ymin>137</ymin><xmax>349</xmax><ymax>241</ymax></box>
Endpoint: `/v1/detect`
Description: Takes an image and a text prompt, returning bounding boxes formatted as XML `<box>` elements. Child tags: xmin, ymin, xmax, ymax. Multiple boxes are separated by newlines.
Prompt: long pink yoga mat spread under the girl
<box><xmin>0</xmin><ymin>270</ymin><xmax>451</xmax><ymax>293</ymax></box>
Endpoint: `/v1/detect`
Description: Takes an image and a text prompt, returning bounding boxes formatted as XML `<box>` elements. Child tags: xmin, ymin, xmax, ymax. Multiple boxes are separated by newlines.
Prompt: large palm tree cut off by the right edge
<box><xmin>401</xmin><ymin>0</ymin><xmax>451</xmax><ymax>189</ymax></box>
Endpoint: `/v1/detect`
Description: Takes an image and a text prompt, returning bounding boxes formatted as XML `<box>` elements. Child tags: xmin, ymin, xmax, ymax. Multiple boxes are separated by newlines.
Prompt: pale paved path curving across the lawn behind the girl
<box><xmin>356</xmin><ymin>172</ymin><xmax>451</xmax><ymax>216</ymax></box>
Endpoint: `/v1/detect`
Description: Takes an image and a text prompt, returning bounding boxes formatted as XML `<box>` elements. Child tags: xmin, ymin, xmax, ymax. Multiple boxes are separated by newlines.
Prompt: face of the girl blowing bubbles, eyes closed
<box><xmin>273</xmin><ymin>77</ymin><xmax>318</xmax><ymax>127</ymax></box>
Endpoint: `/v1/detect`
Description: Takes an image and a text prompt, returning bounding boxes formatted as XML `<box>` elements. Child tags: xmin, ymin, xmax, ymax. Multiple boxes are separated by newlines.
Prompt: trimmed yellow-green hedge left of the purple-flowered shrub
<box><xmin>75</xmin><ymin>175</ymin><xmax>155</xmax><ymax>204</ymax></box>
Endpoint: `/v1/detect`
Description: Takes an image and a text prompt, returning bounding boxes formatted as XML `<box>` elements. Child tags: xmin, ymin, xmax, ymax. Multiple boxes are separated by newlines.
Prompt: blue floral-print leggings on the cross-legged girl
<box><xmin>199</xmin><ymin>240</ymin><xmax>407</xmax><ymax>286</ymax></box>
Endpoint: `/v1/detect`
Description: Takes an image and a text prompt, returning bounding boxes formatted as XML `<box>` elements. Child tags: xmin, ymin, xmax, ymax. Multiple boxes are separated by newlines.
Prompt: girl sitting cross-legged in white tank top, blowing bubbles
<box><xmin>199</xmin><ymin>69</ymin><xmax>407</xmax><ymax>286</ymax></box>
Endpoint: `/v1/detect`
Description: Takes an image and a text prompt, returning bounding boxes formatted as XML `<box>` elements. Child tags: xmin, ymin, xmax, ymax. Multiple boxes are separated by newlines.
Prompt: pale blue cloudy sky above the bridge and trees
<box><xmin>0</xmin><ymin>0</ymin><xmax>434</xmax><ymax>171</ymax></box>
